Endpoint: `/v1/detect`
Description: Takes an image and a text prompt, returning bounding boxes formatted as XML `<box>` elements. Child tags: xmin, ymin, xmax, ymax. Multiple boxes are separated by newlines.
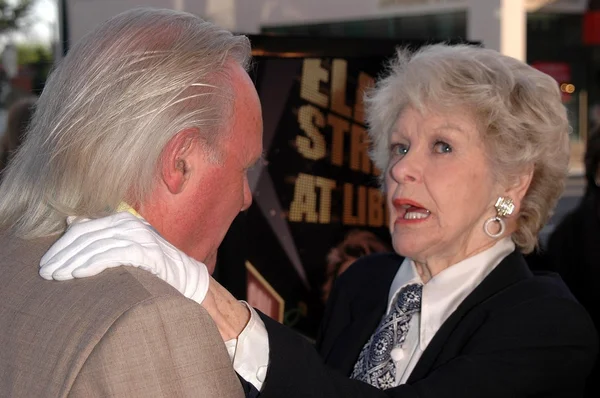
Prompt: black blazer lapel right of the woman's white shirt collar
<box><xmin>407</xmin><ymin>251</ymin><xmax>533</xmax><ymax>384</ymax></box>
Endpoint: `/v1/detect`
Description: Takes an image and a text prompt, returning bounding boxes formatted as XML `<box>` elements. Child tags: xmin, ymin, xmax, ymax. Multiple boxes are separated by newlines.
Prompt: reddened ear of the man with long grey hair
<box><xmin>160</xmin><ymin>129</ymin><xmax>198</xmax><ymax>194</ymax></box>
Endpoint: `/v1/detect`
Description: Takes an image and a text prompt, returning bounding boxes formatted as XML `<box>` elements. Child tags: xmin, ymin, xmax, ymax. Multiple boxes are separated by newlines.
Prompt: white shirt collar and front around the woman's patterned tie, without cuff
<box><xmin>384</xmin><ymin>238</ymin><xmax>515</xmax><ymax>385</ymax></box>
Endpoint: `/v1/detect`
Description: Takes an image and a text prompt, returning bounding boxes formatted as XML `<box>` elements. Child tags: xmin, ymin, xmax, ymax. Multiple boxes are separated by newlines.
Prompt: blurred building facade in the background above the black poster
<box><xmin>61</xmin><ymin>0</ymin><xmax>600</xmax><ymax>174</ymax></box>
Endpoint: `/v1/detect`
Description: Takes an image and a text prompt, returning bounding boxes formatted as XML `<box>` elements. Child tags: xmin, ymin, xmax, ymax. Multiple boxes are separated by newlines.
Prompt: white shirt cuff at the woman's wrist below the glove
<box><xmin>225</xmin><ymin>301</ymin><xmax>269</xmax><ymax>391</ymax></box>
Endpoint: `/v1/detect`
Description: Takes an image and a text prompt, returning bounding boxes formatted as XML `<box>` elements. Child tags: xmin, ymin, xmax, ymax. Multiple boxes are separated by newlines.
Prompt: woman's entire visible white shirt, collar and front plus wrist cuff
<box><xmin>230</xmin><ymin>238</ymin><xmax>515</xmax><ymax>391</ymax></box>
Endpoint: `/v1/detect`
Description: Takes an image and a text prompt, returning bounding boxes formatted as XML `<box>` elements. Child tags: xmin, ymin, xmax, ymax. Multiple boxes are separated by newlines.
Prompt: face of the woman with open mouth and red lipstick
<box><xmin>385</xmin><ymin>107</ymin><xmax>503</xmax><ymax>264</ymax></box>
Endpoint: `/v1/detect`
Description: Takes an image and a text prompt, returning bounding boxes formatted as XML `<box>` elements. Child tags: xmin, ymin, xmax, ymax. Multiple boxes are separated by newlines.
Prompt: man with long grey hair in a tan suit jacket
<box><xmin>0</xmin><ymin>9</ymin><xmax>268</xmax><ymax>397</ymax></box>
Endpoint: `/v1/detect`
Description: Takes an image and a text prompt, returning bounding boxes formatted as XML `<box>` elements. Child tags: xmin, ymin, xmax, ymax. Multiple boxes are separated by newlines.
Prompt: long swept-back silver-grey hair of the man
<box><xmin>0</xmin><ymin>9</ymin><xmax>250</xmax><ymax>238</ymax></box>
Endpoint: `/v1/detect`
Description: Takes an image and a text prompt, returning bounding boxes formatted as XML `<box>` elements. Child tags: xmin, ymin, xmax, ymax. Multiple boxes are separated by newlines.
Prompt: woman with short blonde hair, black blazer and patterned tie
<box><xmin>41</xmin><ymin>45</ymin><xmax>597</xmax><ymax>398</ymax></box>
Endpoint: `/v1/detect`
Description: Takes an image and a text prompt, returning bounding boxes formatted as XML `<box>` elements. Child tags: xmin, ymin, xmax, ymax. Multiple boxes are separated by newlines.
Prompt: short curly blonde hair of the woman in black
<box><xmin>365</xmin><ymin>44</ymin><xmax>570</xmax><ymax>253</ymax></box>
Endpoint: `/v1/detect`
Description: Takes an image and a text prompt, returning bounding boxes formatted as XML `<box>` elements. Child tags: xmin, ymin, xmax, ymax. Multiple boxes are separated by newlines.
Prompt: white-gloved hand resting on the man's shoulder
<box><xmin>39</xmin><ymin>212</ymin><xmax>211</xmax><ymax>304</ymax></box>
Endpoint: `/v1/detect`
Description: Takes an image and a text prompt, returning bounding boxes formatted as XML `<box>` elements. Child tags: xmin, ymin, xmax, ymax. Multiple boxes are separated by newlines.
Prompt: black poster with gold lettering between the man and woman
<box><xmin>216</xmin><ymin>36</ymin><xmax>460</xmax><ymax>339</ymax></box>
